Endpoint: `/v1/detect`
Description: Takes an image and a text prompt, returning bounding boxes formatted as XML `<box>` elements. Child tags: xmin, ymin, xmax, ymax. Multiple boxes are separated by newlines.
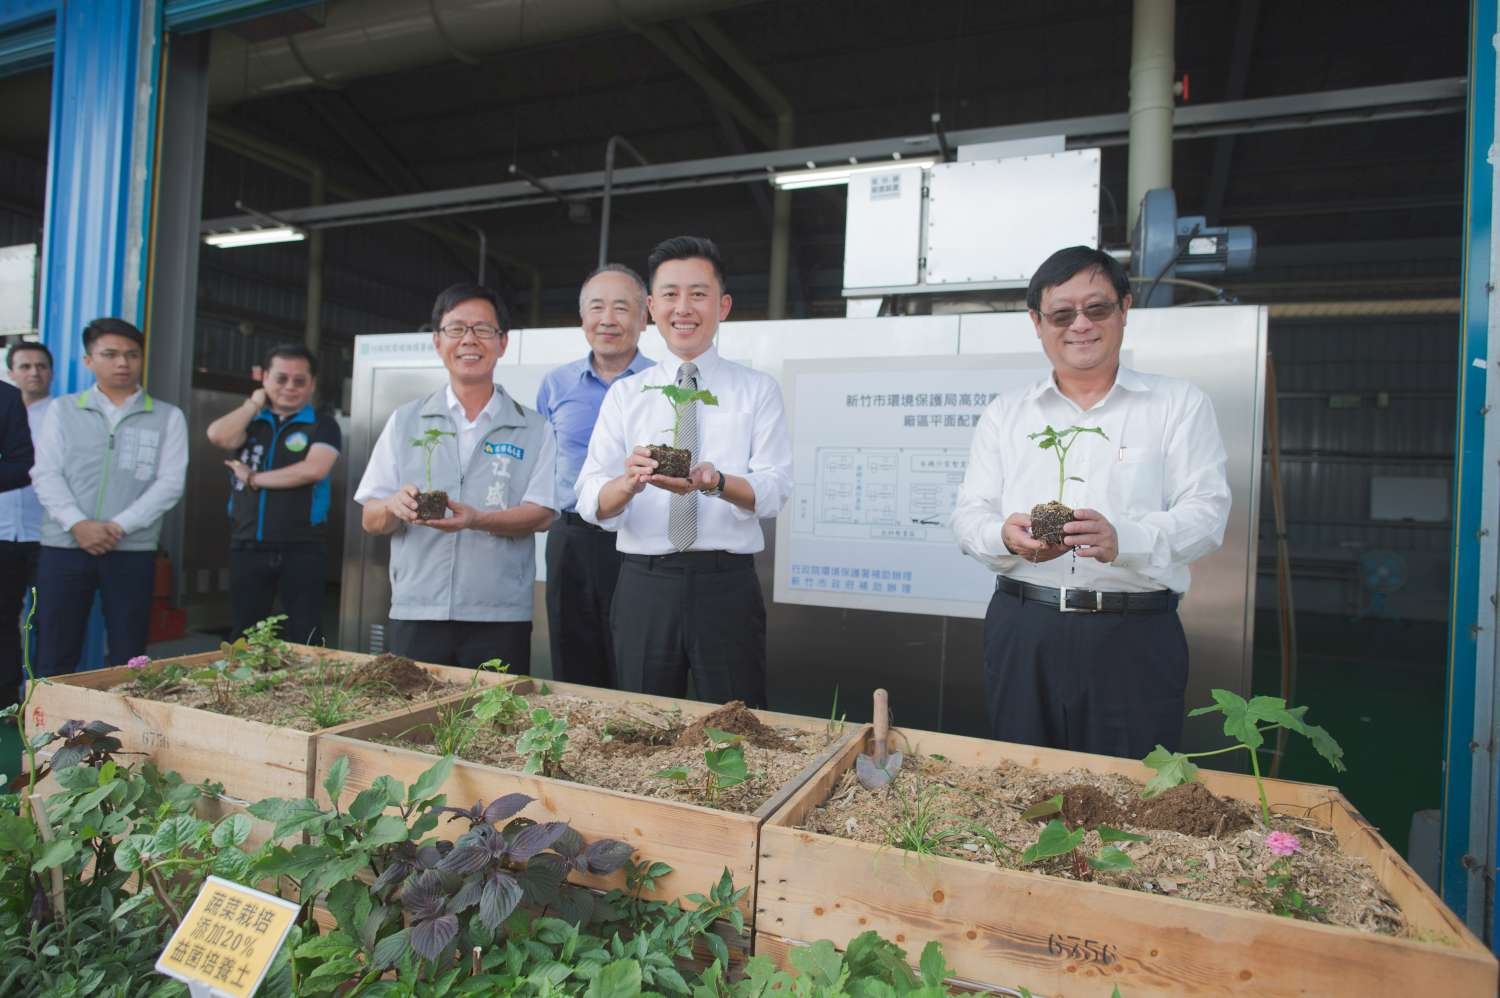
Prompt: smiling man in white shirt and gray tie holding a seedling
<box><xmin>578</xmin><ymin>236</ymin><xmax>792</xmax><ymax>707</ymax></box>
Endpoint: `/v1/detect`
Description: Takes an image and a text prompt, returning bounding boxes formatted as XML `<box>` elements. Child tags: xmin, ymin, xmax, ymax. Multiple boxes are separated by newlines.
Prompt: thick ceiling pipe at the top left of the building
<box><xmin>209</xmin><ymin>0</ymin><xmax>752</xmax><ymax>105</ymax></box>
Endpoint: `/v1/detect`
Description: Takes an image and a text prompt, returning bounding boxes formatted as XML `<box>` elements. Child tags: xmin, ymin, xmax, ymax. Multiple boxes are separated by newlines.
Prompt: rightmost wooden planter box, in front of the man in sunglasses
<box><xmin>756</xmin><ymin>731</ymin><xmax>1497</xmax><ymax>998</ymax></box>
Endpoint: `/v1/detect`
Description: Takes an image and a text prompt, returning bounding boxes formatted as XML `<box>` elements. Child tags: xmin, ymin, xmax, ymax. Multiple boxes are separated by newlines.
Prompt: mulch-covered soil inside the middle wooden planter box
<box><xmin>393</xmin><ymin>693</ymin><xmax>837</xmax><ymax>813</ymax></box>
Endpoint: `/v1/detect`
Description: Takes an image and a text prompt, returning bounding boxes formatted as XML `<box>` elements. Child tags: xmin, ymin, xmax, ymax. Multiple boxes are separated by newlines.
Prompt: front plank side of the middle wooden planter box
<box><xmin>315</xmin><ymin>735</ymin><xmax>759</xmax><ymax>917</ymax></box>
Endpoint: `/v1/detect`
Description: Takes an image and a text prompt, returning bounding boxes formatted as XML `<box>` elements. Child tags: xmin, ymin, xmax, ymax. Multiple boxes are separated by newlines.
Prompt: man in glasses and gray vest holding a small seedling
<box><xmin>354</xmin><ymin>284</ymin><xmax>557</xmax><ymax>674</ymax></box>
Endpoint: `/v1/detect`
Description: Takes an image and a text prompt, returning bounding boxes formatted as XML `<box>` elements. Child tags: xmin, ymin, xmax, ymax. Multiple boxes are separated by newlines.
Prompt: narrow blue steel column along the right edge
<box><xmin>1442</xmin><ymin>0</ymin><xmax>1500</xmax><ymax>948</ymax></box>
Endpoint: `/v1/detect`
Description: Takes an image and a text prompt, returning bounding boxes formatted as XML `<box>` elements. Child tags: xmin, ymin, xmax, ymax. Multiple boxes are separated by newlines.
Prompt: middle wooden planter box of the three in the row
<box><xmin>312</xmin><ymin>680</ymin><xmax>864</xmax><ymax>927</ymax></box>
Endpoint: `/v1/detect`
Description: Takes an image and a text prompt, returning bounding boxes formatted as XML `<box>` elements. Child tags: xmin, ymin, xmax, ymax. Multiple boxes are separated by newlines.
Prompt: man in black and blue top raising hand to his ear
<box><xmin>209</xmin><ymin>344</ymin><xmax>344</xmax><ymax>644</ymax></box>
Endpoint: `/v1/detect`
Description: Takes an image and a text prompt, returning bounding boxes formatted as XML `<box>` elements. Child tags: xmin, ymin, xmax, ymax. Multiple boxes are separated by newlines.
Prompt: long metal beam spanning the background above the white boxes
<box><xmin>204</xmin><ymin>77</ymin><xmax>1467</xmax><ymax>231</ymax></box>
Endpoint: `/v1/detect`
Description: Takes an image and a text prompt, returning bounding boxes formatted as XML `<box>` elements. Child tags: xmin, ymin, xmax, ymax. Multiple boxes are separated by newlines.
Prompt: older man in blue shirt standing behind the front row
<box><xmin>537</xmin><ymin>263</ymin><xmax>656</xmax><ymax>686</ymax></box>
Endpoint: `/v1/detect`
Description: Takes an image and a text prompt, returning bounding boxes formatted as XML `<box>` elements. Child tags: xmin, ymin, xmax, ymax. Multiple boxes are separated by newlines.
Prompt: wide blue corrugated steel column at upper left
<box><xmin>41</xmin><ymin>0</ymin><xmax>162</xmax><ymax>392</ymax></box>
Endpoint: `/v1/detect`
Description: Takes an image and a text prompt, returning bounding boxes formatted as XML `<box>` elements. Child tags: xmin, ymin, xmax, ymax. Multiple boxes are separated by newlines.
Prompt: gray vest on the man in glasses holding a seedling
<box><xmin>390</xmin><ymin>386</ymin><xmax>554</xmax><ymax>621</ymax></box>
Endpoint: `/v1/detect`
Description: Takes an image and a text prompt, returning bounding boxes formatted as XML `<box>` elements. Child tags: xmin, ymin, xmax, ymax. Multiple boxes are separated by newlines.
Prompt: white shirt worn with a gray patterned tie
<box><xmin>578</xmin><ymin>347</ymin><xmax>792</xmax><ymax>554</ymax></box>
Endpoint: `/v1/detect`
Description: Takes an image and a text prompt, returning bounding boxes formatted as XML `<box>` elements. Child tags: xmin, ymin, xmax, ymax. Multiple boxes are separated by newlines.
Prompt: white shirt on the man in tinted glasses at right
<box><xmin>953</xmin><ymin>368</ymin><xmax>1230</xmax><ymax>593</ymax></box>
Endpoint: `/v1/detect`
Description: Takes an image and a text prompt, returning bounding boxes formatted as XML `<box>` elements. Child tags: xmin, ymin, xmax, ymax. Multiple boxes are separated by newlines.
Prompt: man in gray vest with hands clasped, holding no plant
<box><xmin>32</xmin><ymin>318</ymin><xmax>188</xmax><ymax>675</ymax></box>
